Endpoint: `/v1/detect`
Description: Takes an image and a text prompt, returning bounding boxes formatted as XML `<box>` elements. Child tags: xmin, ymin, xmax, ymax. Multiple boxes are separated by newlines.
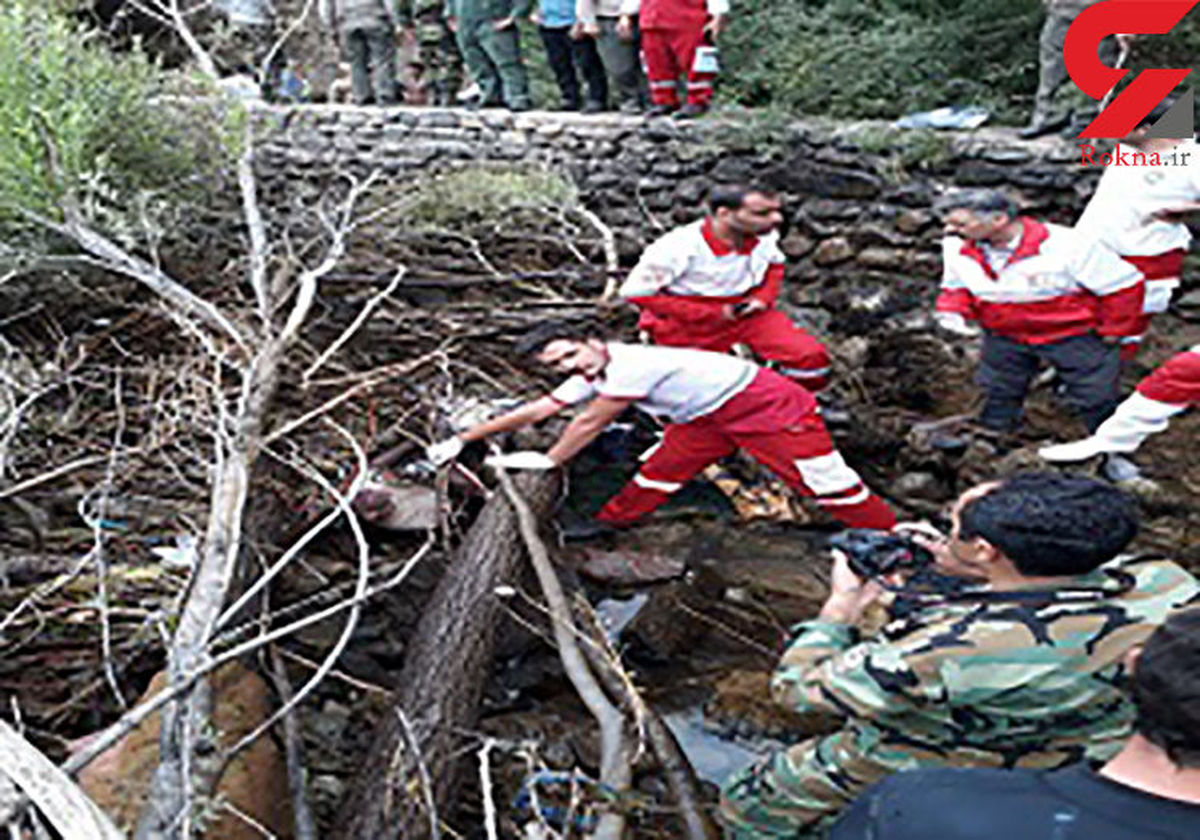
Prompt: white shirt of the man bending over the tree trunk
<box><xmin>550</xmin><ymin>342</ymin><xmax>758</xmax><ymax>422</ymax></box>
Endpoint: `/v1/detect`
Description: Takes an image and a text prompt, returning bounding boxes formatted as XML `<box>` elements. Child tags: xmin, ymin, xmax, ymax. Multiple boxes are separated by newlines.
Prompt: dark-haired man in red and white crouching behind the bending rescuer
<box><xmin>620</xmin><ymin>185</ymin><xmax>829</xmax><ymax>391</ymax></box>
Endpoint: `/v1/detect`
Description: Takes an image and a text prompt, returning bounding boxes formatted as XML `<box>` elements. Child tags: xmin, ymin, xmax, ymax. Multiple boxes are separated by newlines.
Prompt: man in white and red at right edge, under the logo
<box><xmin>1075</xmin><ymin>107</ymin><xmax>1200</xmax><ymax>359</ymax></box>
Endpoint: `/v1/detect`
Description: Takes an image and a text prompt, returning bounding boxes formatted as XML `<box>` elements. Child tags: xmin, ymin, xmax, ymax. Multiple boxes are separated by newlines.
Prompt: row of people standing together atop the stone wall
<box><xmin>318</xmin><ymin>0</ymin><xmax>728</xmax><ymax>119</ymax></box>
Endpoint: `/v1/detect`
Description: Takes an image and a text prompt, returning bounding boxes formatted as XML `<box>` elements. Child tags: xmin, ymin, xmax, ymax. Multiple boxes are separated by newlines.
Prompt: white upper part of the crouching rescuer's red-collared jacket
<box><xmin>619</xmin><ymin>220</ymin><xmax>786</xmax><ymax>298</ymax></box>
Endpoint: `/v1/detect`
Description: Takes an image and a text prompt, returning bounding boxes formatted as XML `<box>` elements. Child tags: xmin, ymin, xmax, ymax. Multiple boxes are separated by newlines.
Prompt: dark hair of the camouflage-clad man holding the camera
<box><xmin>959</xmin><ymin>472</ymin><xmax>1138</xmax><ymax>576</ymax></box>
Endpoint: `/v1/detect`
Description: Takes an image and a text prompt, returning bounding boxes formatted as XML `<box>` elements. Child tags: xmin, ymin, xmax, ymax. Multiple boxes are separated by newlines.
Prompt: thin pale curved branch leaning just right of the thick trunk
<box><xmin>496</xmin><ymin>469</ymin><xmax>634</xmax><ymax>840</ymax></box>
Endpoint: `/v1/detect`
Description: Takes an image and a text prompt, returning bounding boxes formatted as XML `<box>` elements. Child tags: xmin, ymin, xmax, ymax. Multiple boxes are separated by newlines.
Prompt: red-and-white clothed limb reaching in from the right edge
<box><xmin>1039</xmin><ymin>344</ymin><xmax>1200</xmax><ymax>462</ymax></box>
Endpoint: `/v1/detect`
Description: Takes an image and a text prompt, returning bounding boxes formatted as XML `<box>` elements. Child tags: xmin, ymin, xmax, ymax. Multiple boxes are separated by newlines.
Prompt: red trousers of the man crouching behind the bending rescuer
<box><xmin>641</xmin><ymin>310</ymin><xmax>829</xmax><ymax>391</ymax></box>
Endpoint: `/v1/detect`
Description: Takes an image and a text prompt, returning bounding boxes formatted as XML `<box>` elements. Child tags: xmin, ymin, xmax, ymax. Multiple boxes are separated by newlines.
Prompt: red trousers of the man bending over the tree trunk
<box><xmin>596</xmin><ymin>371</ymin><xmax>896</xmax><ymax>529</ymax></box>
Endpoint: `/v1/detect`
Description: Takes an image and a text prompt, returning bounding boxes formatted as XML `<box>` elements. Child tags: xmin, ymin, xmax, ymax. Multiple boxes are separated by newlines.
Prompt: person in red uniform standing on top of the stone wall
<box><xmin>620</xmin><ymin>0</ymin><xmax>730</xmax><ymax>119</ymax></box>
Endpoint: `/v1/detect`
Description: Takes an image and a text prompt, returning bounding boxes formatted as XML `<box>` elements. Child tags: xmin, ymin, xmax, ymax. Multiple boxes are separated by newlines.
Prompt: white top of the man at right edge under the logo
<box><xmin>1075</xmin><ymin>140</ymin><xmax>1200</xmax><ymax>257</ymax></box>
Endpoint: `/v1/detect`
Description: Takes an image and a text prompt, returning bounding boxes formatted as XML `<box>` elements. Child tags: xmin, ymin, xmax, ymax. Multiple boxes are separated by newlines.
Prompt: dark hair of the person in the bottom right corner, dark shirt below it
<box><xmin>1133</xmin><ymin>607</ymin><xmax>1200</xmax><ymax>768</ymax></box>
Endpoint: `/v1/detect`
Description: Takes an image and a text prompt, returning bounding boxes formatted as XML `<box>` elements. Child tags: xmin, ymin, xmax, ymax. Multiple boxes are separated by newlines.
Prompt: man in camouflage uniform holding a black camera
<box><xmin>720</xmin><ymin>473</ymin><xmax>1200</xmax><ymax>840</ymax></box>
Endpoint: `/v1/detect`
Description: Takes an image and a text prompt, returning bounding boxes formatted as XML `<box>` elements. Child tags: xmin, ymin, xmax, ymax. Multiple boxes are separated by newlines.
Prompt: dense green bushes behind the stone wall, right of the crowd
<box><xmin>721</xmin><ymin>0</ymin><xmax>1042</xmax><ymax>121</ymax></box>
